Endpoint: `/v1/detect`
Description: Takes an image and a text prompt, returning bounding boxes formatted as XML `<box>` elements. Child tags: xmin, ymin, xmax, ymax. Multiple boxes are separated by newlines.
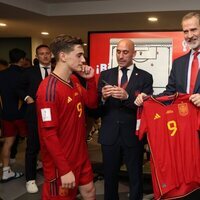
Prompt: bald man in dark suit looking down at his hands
<box><xmin>98</xmin><ymin>39</ymin><xmax>153</xmax><ymax>200</ymax></box>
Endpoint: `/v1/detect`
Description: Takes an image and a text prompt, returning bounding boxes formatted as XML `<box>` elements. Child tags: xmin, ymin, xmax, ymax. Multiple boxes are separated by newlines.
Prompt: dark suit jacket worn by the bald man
<box><xmin>98</xmin><ymin>66</ymin><xmax>153</xmax><ymax>147</ymax></box>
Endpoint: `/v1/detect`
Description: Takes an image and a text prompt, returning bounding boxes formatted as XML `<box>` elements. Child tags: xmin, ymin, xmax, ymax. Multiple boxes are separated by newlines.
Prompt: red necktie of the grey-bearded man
<box><xmin>190</xmin><ymin>51</ymin><xmax>200</xmax><ymax>94</ymax></box>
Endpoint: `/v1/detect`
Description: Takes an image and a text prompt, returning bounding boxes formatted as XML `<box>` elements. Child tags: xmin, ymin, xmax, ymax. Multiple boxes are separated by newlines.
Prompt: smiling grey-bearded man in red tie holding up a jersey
<box><xmin>135</xmin><ymin>12</ymin><xmax>200</xmax><ymax>200</ymax></box>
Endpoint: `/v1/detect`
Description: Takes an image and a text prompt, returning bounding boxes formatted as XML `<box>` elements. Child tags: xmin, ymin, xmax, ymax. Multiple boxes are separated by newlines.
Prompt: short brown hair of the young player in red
<box><xmin>50</xmin><ymin>34</ymin><xmax>83</xmax><ymax>60</ymax></box>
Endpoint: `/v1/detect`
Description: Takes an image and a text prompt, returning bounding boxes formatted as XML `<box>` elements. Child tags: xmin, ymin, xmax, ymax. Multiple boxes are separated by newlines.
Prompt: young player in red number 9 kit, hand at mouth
<box><xmin>36</xmin><ymin>35</ymin><xmax>97</xmax><ymax>200</ymax></box>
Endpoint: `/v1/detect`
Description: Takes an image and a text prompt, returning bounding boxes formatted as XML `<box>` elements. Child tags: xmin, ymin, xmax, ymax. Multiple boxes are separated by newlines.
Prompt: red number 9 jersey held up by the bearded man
<box><xmin>137</xmin><ymin>93</ymin><xmax>200</xmax><ymax>199</ymax></box>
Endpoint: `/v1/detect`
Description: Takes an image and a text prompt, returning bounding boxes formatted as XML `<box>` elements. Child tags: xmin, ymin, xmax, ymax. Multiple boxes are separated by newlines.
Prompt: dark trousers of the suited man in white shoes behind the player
<box><xmin>25</xmin><ymin>104</ymin><xmax>40</xmax><ymax>181</ymax></box>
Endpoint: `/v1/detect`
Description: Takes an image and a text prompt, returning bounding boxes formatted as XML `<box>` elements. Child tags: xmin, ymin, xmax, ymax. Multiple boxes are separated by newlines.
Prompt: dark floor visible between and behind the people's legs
<box><xmin>0</xmin><ymin>134</ymin><xmax>200</xmax><ymax>200</ymax></box>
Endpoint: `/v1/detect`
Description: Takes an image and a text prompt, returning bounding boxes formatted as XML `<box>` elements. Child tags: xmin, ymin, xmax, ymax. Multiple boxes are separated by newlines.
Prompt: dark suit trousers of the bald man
<box><xmin>102</xmin><ymin>138</ymin><xmax>143</xmax><ymax>200</ymax></box>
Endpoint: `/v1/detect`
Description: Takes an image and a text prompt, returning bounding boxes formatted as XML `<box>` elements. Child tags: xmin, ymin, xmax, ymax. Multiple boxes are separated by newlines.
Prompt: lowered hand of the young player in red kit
<box><xmin>61</xmin><ymin>171</ymin><xmax>76</xmax><ymax>189</ymax></box>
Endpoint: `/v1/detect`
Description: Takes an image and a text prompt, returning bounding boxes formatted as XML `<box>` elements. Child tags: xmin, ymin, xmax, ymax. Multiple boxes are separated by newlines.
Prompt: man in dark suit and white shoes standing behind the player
<box><xmin>19</xmin><ymin>45</ymin><xmax>52</xmax><ymax>193</ymax></box>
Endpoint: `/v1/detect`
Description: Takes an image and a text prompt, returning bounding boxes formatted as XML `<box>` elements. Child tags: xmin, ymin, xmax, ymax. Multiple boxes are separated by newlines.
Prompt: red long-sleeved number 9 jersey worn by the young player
<box><xmin>36</xmin><ymin>74</ymin><xmax>97</xmax><ymax>181</ymax></box>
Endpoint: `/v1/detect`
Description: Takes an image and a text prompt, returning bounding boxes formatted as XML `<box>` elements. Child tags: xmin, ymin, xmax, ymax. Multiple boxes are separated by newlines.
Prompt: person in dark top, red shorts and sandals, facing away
<box><xmin>0</xmin><ymin>48</ymin><xmax>27</xmax><ymax>183</ymax></box>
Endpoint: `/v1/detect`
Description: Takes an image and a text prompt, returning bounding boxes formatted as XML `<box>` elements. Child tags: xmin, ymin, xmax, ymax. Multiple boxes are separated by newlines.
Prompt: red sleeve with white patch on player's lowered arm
<box><xmin>36</xmin><ymin>82</ymin><xmax>71</xmax><ymax>176</ymax></box>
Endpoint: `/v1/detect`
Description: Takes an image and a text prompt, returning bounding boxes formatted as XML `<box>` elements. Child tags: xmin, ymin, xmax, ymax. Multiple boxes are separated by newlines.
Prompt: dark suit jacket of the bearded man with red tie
<box><xmin>164</xmin><ymin>52</ymin><xmax>200</xmax><ymax>94</ymax></box>
